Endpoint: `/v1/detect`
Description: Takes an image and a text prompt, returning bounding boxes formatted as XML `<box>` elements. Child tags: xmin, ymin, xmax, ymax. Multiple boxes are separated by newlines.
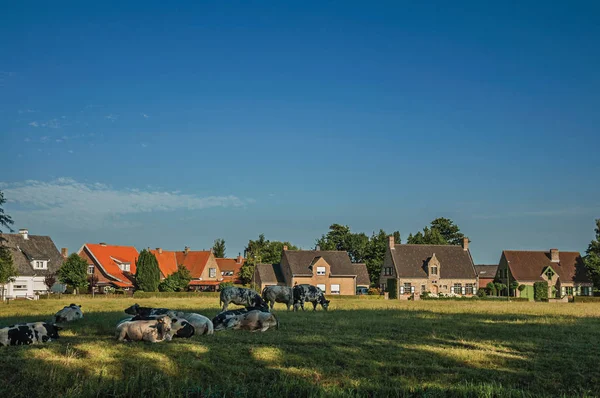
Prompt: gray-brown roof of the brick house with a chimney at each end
<box><xmin>392</xmin><ymin>244</ymin><xmax>476</xmax><ymax>279</ymax></box>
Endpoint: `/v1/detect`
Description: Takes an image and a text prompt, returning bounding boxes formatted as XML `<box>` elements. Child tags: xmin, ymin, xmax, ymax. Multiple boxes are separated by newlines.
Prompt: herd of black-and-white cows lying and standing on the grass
<box><xmin>0</xmin><ymin>285</ymin><xmax>329</xmax><ymax>346</ymax></box>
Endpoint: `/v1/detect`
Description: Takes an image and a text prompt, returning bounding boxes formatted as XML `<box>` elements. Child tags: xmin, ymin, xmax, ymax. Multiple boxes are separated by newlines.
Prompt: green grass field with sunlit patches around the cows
<box><xmin>0</xmin><ymin>297</ymin><xmax>600</xmax><ymax>397</ymax></box>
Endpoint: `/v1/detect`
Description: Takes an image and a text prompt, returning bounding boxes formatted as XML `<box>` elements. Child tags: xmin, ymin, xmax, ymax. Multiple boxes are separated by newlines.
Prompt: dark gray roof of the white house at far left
<box><xmin>0</xmin><ymin>234</ymin><xmax>64</xmax><ymax>276</ymax></box>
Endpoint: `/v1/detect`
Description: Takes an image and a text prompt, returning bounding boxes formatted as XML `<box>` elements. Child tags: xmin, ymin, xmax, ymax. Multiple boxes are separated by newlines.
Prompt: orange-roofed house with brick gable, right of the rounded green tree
<box><xmin>175</xmin><ymin>246</ymin><xmax>224</xmax><ymax>292</ymax></box>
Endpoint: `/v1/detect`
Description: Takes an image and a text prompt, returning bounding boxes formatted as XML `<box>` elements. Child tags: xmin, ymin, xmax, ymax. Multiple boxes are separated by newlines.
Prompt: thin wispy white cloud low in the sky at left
<box><xmin>0</xmin><ymin>177</ymin><xmax>254</xmax><ymax>228</ymax></box>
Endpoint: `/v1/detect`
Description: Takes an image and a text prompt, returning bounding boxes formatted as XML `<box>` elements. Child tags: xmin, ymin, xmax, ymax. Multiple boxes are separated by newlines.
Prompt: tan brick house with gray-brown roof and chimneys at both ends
<box><xmin>379</xmin><ymin>236</ymin><xmax>478</xmax><ymax>299</ymax></box>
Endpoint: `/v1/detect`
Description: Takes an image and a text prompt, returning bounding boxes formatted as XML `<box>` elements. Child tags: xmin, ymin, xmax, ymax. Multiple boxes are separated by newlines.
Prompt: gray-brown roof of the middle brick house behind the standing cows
<box><xmin>282</xmin><ymin>250</ymin><xmax>356</xmax><ymax>276</ymax></box>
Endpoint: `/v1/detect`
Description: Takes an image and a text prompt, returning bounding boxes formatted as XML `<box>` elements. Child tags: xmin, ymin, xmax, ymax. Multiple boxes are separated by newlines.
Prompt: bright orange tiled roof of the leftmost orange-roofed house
<box><xmin>82</xmin><ymin>243</ymin><xmax>139</xmax><ymax>287</ymax></box>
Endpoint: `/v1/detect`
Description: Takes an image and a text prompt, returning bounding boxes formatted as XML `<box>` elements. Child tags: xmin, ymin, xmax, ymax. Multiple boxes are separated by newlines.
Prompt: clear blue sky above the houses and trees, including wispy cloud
<box><xmin>0</xmin><ymin>1</ymin><xmax>600</xmax><ymax>263</ymax></box>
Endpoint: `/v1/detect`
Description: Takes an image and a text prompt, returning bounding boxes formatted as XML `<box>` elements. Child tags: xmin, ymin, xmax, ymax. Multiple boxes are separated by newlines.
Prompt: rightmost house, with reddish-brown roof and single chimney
<box><xmin>498</xmin><ymin>249</ymin><xmax>593</xmax><ymax>300</ymax></box>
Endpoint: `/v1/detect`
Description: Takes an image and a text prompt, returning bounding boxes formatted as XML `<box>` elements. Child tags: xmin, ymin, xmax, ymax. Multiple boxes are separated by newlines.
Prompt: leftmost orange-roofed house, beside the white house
<box><xmin>78</xmin><ymin>243</ymin><xmax>139</xmax><ymax>292</ymax></box>
